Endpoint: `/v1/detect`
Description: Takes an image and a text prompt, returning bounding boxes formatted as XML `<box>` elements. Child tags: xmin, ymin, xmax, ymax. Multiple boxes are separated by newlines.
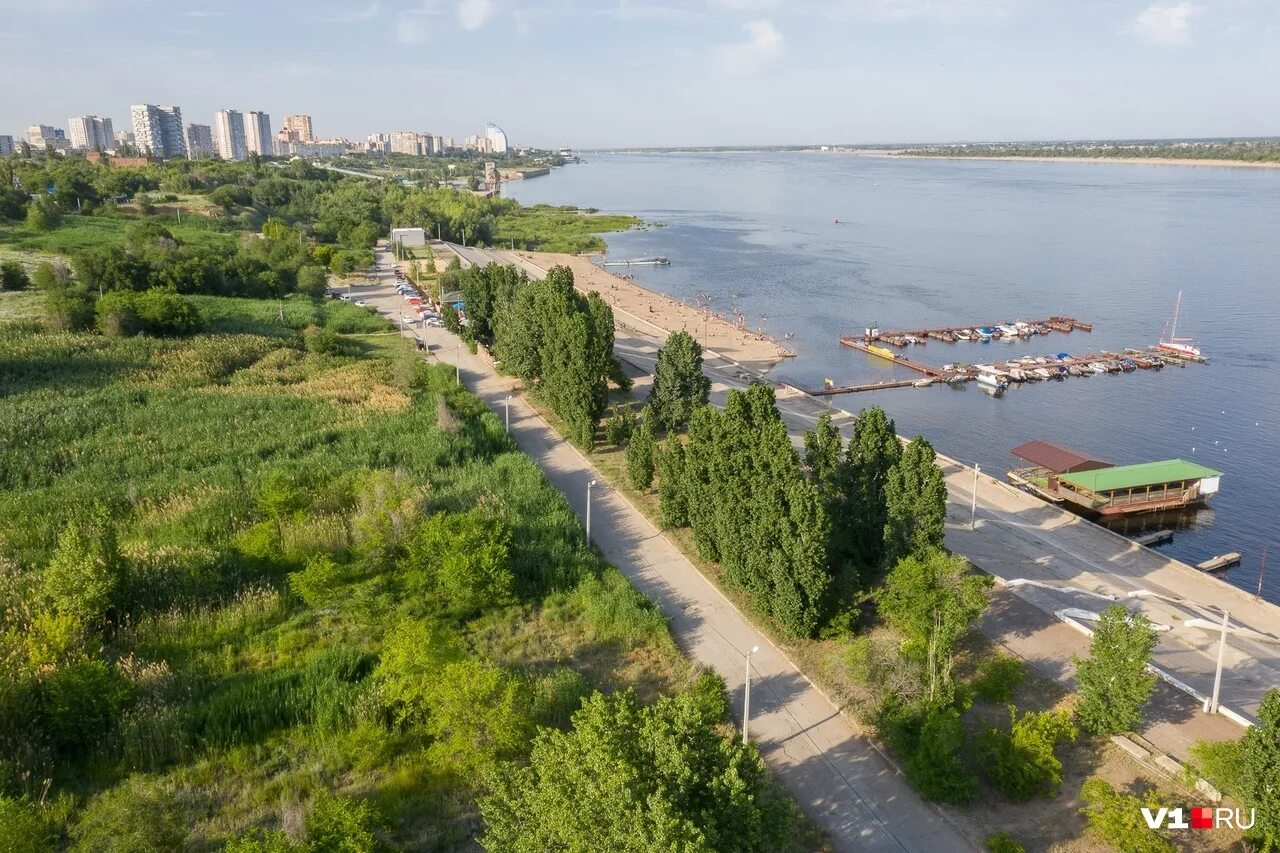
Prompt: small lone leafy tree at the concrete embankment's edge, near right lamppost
<box><xmin>1071</xmin><ymin>605</ymin><xmax>1156</xmax><ymax>735</ymax></box>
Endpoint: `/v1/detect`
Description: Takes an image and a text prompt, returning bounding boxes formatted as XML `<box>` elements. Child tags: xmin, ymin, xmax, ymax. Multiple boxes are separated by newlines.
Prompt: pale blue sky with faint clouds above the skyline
<box><xmin>0</xmin><ymin>0</ymin><xmax>1280</xmax><ymax>149</ymax></box>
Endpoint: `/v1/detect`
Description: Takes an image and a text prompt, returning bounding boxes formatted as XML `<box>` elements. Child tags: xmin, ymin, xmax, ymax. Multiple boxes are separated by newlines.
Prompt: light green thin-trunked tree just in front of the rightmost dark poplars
<box><xmin>877</xmin><ymin>549</ymin><xmax>991</xmax><ymax>704</ymax></box>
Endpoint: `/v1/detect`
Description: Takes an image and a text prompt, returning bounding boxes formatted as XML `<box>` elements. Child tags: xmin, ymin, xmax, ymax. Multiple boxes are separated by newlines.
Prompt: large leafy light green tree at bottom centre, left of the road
<box><xmin>480</xmin><ymin>675</ymin><xmax>791</xmax><ymax>853</ymax></box>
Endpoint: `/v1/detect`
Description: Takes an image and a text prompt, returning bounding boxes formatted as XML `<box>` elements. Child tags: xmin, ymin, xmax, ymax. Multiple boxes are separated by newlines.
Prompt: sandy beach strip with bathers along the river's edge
<box><xmin>516</xmin><ymin>252</ymin><xmax>795</xmax><ymax>373</ymax></box>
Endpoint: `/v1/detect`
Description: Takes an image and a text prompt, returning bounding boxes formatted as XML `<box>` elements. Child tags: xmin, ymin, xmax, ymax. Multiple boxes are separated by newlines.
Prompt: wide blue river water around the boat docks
<box><xmin>503</xmin><ymin>152</ymin><xmax>1280</xmax><ymax>602</ymax></box>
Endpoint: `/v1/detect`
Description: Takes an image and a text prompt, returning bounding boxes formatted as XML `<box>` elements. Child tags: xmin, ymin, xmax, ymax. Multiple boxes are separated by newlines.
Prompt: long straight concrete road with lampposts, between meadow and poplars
<box><xmin>358</xmin><ymin>252</ymin><xmax>974</xmax><ymax>852</ymax></box>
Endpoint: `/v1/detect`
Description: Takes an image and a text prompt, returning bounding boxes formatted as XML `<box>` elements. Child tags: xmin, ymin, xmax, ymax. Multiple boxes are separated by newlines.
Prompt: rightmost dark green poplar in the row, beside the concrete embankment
<box><xmin>883</xmin><ymin>435</ymin><xmax>947</xmax><ymax>565</ymax></box>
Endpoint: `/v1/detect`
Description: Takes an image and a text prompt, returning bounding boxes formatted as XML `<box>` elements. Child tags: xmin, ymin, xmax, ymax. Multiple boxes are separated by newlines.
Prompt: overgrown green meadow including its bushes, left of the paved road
<box><xmin>0</xmin><ymin>295</ymin><xmax>742</xmax><ymax>850</ymax></box>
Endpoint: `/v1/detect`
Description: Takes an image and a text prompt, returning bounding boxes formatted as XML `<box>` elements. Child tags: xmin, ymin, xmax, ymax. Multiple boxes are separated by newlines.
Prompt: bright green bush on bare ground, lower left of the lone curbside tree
<box><xmin>979</xmin><ymin>706</ymin><xmax>1078</xmax><ymax>803</ymax></box>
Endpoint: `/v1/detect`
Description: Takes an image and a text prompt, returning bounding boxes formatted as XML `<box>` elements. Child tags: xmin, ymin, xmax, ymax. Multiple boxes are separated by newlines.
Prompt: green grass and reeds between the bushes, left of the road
<box><xmin>0</xmin><ymin>298</ymin><xmax>690</xmax><ymax>848</ymax></box>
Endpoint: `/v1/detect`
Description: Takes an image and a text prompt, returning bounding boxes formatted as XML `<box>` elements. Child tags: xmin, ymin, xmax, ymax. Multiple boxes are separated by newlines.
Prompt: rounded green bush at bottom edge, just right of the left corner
<box><xmin>70</xmin><ymin>776</ymin><xmax>187</xmax><ymax>853</ymax></box>
